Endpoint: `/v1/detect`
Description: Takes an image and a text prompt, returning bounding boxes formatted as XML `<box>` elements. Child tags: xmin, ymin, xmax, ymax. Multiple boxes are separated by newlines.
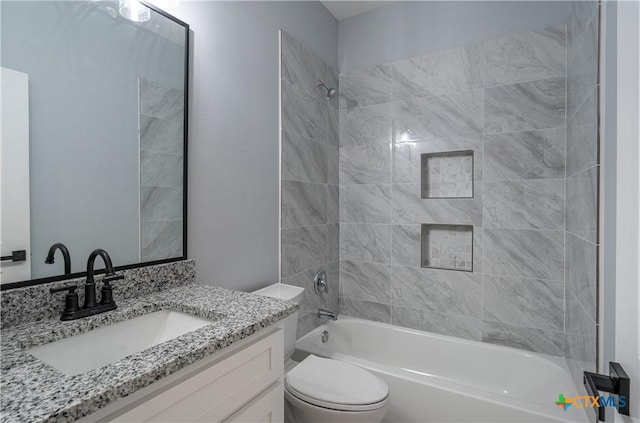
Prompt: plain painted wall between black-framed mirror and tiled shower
<box><xmin>162</xmin><ymin>1</ymin><xmax>338</xmax><ymax>291</ymax></box>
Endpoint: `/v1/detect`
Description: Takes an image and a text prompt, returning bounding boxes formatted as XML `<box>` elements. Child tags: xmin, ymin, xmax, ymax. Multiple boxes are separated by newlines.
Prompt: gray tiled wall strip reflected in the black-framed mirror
<box><xmin>139</xmin><ymin>78</ymin><xmax>184</xmax><ymax>261</ymax></box>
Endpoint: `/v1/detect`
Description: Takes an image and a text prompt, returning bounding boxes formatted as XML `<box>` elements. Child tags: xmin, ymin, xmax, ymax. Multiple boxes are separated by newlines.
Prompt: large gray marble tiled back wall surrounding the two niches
<box><xmin>339</xmin><ymin>25</ymin><xmax>568</xmax><ymax>356</ymax></box>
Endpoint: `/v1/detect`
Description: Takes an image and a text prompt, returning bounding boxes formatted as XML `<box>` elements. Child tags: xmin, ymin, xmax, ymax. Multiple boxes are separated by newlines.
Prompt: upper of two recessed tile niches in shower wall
<box><xmin>420</xmin><ymin>150</ymin><xmax>473</xmax><ymax>198</ymax></box>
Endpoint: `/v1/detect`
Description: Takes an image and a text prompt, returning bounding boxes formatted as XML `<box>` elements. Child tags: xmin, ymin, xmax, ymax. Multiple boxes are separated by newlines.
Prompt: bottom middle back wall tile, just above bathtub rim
<box><xmin>391</xmin><ymin>306</ymin><xmax>482</xmax><ymax>341</ymax></box>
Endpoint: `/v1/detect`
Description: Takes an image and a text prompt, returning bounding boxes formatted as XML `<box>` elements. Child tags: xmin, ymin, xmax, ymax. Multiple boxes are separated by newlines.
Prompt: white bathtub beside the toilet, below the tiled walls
<box><xmin>294</xmin><ymin>316</ymin><xmax>591</xmax><ymax>423</ymax></box>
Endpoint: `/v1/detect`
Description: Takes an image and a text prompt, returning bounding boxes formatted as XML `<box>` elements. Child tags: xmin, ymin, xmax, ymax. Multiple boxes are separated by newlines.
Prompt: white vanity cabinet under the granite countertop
<box><xmin>81</xmin><ymin>325</ymin><xmax>284</xmax><ymax>422</ymax></box>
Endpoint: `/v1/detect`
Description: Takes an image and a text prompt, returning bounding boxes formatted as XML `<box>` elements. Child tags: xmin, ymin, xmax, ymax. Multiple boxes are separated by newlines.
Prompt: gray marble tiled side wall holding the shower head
<box><xmin>280</xmin><ymin>31</ymin><xmax>340</xmax><ymax>337</ymax></box>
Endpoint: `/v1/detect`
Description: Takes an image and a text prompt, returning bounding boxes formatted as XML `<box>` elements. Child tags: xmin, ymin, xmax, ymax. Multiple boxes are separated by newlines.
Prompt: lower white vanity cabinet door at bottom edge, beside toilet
<box><xmin>224</xmin><ymin>382</ymin><xmax>284</xmax><ymax>423</ymax></box>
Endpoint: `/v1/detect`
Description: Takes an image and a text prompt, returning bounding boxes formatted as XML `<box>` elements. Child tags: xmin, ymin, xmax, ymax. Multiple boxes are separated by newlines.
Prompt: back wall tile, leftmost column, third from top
<box><xmin>340</xmin><ymin>144</ymin><xmax>391</xmax><ymax>184</ymax></box>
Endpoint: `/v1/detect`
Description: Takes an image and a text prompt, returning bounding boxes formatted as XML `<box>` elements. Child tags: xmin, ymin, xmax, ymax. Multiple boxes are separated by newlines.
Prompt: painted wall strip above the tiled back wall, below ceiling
<box><xmin>338</xmin><ymin>1</ymin><xmax>569</xmax><ymax>73</ymax></box>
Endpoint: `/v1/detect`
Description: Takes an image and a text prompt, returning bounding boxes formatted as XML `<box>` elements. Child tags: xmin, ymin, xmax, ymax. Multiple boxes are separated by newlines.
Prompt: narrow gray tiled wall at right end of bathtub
<box><xmin>565</xmin><ymin>1</ymin><xmax>600</xmax><ymax>392</ymax></box>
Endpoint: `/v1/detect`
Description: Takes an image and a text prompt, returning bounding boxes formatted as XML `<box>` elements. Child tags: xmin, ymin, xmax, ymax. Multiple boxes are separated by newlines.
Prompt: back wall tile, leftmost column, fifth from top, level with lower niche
<box><xmin>340</xmin><ymin>223</ymin><xmax>391</xmax><ymax>263</ymax></box>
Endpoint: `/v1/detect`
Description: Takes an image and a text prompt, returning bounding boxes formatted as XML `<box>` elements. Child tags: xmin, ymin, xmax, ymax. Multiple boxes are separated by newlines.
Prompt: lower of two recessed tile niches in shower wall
<box><xmin>421</xmin><ymin>224</ymin><xmax>473</xmax><ymax>272</ymax></box>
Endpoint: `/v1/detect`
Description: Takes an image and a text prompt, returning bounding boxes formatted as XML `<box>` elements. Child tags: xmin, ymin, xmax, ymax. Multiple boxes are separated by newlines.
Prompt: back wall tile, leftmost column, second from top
<box><xmin>339</xmin><ymin>103</ymin><xmax>391</xmax><ymax>147</ymax></box>
